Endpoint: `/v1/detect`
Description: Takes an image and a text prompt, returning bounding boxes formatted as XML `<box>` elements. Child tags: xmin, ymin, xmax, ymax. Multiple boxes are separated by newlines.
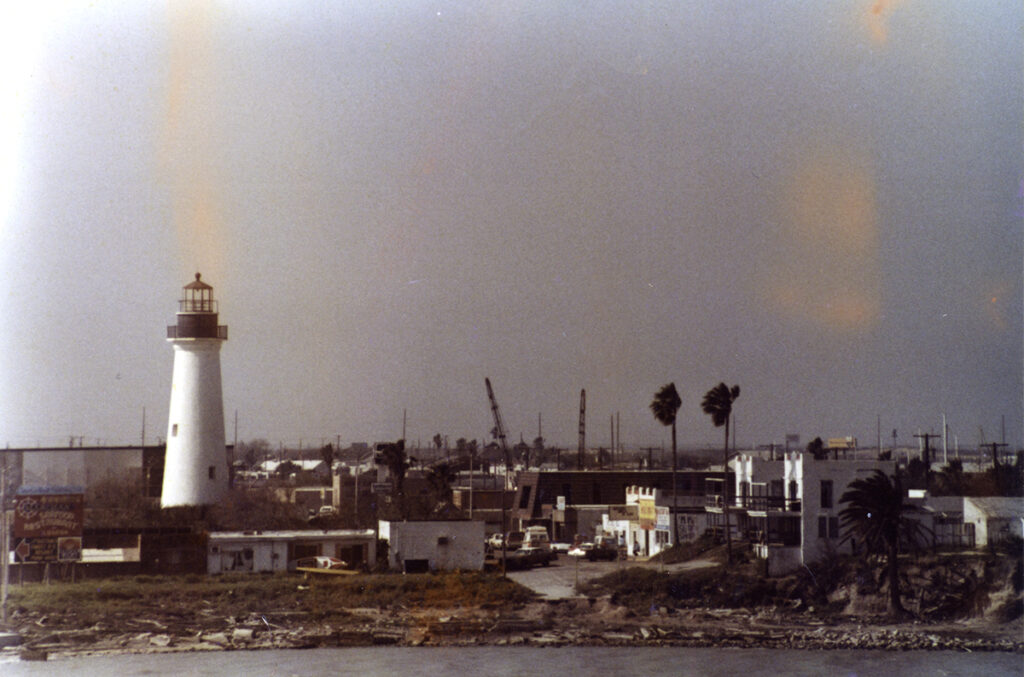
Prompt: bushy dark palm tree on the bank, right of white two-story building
<box><xmin>839</xmin><ymin>470</ymin><xmax>923</xmax><ymax>615</ymax></box>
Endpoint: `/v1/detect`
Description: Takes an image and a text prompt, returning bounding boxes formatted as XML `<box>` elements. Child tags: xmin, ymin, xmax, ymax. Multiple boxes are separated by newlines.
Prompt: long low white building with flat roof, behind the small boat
<box><xmin>206</xmin><ymin>528</ymin><xmax>377</xmax><ymax>574</ymax></box>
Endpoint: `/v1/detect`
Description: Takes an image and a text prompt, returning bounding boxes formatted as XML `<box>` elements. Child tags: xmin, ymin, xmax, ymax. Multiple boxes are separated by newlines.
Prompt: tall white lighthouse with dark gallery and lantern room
<box><xmin>160</xmin><ymin>272</ymin><xmax>227</xmax><ymax>508</ymax></box>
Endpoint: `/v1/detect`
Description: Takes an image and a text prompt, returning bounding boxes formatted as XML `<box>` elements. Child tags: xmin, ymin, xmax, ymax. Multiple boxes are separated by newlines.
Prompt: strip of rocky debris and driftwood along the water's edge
<box><xmin>4</xmin><ymin>598</ymin><xmax>1024</xmax><ymax>657</ymax></box>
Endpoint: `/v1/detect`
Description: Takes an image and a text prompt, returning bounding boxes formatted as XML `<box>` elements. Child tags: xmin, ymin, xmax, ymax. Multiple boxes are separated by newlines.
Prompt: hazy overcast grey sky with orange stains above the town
<box><xmin>0</xmin><ymin>0</ymin><xmax>1024</xmax><ymax>447</ymax></box>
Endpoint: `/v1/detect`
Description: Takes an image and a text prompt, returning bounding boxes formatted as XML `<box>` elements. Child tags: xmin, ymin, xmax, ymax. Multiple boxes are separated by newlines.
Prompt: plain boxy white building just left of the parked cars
<box><xmin>380</xmin><ymin>519</ymin><xmax>485</xmax><ymax>574</ymax></box>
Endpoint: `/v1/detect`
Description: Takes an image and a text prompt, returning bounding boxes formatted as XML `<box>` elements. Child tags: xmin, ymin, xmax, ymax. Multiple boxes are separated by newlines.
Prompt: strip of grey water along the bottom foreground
<box><xmin>0</xmin><ymin>646</ymin><xmax>1024</xmax><ymax>677</ymax></box>
